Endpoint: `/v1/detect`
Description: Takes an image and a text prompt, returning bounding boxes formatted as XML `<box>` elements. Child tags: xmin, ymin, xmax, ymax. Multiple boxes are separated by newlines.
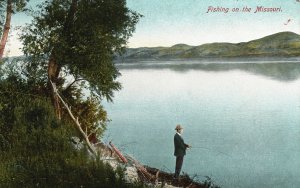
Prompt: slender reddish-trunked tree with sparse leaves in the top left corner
<box><xmin>0</xmin><ymin>0</ymin><xmax>29</xmax><ymax>59</ymax></box>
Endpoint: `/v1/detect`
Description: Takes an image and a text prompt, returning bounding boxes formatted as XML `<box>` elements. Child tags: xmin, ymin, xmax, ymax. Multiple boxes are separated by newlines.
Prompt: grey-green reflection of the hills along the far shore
<box><xmin>117</xmin><ymin>60</ymin><xmax>300</xmax><ymax>82</ymax></box>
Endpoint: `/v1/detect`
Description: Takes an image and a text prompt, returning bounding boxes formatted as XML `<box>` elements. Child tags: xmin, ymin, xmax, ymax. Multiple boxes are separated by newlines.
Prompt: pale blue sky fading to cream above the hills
<box><xmin>6</xmin><ymin>0</ymin><xmax>300</xmax><ymax>56</ymax></box>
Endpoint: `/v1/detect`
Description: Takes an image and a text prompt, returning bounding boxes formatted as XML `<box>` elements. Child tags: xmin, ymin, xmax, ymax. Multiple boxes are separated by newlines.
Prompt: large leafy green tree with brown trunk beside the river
<box><xmin>21</xmin><ymin>0</ymin><xmax>140</xmax><ymax>152</ymax></box>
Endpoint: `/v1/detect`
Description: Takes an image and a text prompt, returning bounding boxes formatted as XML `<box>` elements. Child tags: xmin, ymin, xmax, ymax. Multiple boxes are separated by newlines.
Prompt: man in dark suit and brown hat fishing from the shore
<box><xmin>174</xmin><ymin>125</ymin><xmax>190</xmax><ymax>179</ymax></box>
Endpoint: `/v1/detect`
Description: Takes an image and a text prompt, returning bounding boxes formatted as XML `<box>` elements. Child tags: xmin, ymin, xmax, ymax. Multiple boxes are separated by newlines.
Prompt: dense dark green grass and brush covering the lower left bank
<box><xmin>0</xmin><ymin>69</ymin><xmax>144</xmax><ymax>187</ymax></box>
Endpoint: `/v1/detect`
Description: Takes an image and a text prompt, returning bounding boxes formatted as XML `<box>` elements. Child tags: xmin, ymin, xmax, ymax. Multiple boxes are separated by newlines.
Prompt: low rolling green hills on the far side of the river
<box><xmin>117</xmin><ymin>32</ymin><xmax>300</xmax><ymax>60</ymax></box>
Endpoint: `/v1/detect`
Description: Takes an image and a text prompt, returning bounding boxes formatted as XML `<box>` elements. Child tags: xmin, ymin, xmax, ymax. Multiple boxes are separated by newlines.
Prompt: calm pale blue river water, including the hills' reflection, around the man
<box><xmin>104</xmin><ymin>61</ymin><xmax>300</xmax><ymax>188</ymax></box>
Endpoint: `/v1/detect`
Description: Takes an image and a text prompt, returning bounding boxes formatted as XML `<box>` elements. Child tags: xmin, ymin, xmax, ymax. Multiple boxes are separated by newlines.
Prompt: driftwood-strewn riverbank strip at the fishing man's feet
<box><xmin>95</xmin><ymin>143</ymin><xmax>218</xmax><ymax>188</ymax></box>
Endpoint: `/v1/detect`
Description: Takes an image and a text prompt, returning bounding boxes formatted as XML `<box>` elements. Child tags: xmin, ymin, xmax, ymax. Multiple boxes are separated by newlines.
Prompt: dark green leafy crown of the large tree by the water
<box><xmin>21</xmin><ymin>0</ymin><xmax>140</xmax><ymax>100</ymax></box>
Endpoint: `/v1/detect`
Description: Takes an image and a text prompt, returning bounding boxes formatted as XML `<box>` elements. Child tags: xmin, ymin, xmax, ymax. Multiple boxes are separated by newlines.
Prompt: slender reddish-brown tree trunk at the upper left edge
<box><xmin>0</xmin><ymin>0</ymin><xmax>13</xmax><ymax>59</ymax></box>
